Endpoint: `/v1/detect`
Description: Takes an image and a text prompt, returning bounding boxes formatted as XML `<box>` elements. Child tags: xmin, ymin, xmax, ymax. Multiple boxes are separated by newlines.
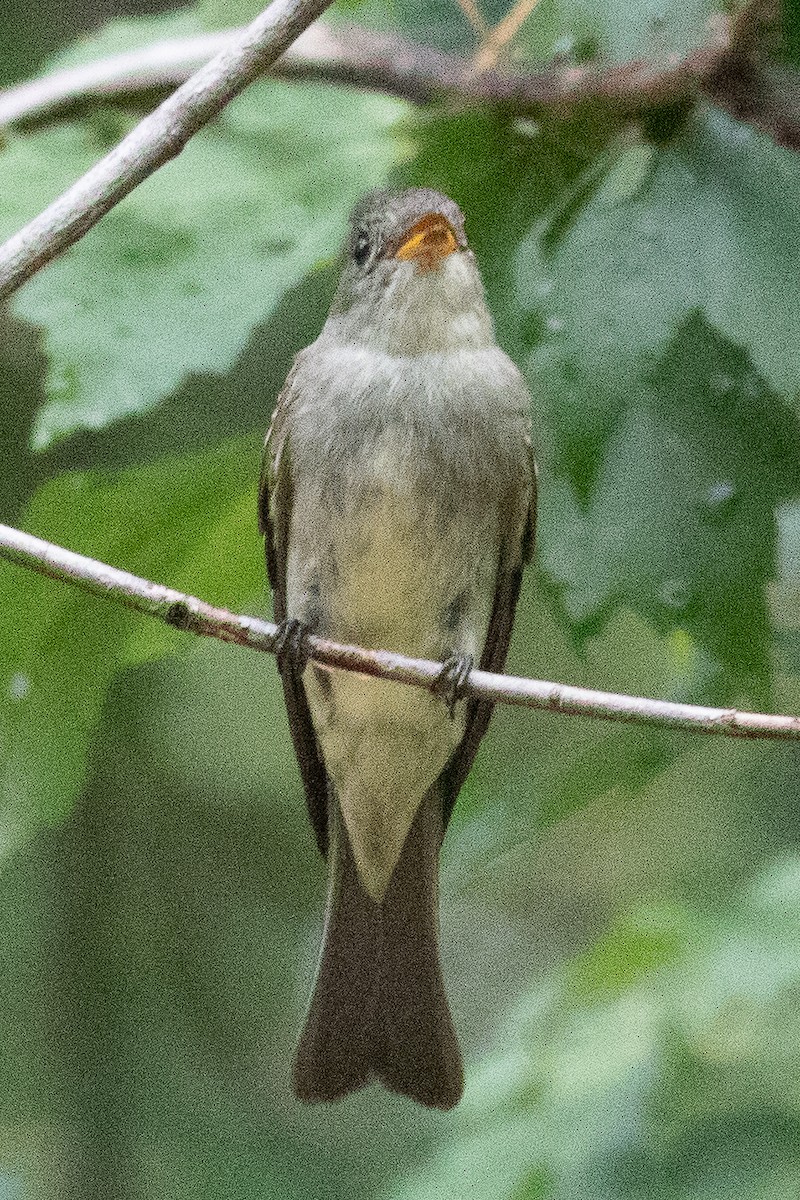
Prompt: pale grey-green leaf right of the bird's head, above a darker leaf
<box><xmin>519</xmin><ymin>109</ymin><xmax>800</xmax><ymax>408</ymax></box>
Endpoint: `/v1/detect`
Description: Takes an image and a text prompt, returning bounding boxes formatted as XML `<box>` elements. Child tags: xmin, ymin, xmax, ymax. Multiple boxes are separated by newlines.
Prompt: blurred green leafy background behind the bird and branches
<box><xmin>0</xmin><ymin>0</ymin><xmax>800</xmax><ymax>1200</ymax></box>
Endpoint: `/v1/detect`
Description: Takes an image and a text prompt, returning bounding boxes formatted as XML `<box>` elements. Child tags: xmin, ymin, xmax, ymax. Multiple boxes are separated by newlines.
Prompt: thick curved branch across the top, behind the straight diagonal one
<box><xmin>0</xmin><ymin>0</ymin><xmax>800</xmax><ymax>149</ymax></box>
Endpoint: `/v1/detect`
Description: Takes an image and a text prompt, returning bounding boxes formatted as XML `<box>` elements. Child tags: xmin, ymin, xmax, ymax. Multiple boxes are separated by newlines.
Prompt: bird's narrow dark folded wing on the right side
<box><xmin>439</xmin><ymin>442</ymin><xmax>536</xmax><ymax>828</ymax></box>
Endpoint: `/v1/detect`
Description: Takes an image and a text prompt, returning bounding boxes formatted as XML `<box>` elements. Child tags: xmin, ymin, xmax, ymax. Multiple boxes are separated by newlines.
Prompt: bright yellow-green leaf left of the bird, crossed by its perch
<box><xmin>0</xmin><ymin>440</ymin><xmax>263</xmax><ymax>846</ymax></box>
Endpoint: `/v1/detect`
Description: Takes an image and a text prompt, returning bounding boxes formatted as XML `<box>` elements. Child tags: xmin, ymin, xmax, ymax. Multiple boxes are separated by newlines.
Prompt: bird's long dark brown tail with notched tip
<box><xmin>294</xmin><ymin>792</ymin><xmax>464</xmax><ymax>1109</ymax></box>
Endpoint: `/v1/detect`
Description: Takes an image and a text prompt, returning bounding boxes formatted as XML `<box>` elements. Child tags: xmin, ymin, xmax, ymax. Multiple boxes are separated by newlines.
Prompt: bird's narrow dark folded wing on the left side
<box><xmin>258</xmin><ymin>367</ymin><xmax>329</xmax><ymax>856</ymax></box>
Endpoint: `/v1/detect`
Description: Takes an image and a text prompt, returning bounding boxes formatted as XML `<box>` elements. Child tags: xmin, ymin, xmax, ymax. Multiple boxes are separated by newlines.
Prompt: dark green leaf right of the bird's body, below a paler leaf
<box><xmin>540</xmin><ymin>314</ymin><xmax>800</xmax><ymax>698</ymax></box>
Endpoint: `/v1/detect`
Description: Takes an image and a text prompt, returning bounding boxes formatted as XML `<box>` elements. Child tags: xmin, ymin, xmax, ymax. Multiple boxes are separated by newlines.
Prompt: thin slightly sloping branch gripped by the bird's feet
<box><xmin>0</xmin><ymin>524</ymin><xmax>800</xmax><ymax>742</ymax></box>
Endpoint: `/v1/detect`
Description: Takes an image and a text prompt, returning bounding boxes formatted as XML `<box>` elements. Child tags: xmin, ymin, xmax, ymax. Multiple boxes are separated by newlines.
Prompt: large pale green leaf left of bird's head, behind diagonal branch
<box><xmin>0</xmin><ymin>11</ymin><xmax>405</xmax><ymax>448</ymax></box>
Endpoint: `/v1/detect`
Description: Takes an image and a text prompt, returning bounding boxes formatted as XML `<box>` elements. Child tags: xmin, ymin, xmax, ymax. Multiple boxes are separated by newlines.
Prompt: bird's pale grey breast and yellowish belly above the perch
<box><xmin>290</xmin><ymin>349</ymin><xmax>528</xmax><ymax>656</ymax></box>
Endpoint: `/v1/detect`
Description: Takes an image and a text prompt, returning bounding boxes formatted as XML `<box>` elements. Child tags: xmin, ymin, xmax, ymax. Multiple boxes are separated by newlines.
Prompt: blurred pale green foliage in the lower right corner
<box><xmin>390</xmin><ymin>856</ymin><xmax>800</xmax><ymax>1200</ymax></box>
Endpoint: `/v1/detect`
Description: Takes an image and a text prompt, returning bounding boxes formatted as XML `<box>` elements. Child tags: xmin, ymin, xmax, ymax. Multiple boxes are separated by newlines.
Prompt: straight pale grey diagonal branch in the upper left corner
<box><xmin>0</xmin><ymin>0</ymin><xmax>331</xmax><ymax>300</ymax></box>
